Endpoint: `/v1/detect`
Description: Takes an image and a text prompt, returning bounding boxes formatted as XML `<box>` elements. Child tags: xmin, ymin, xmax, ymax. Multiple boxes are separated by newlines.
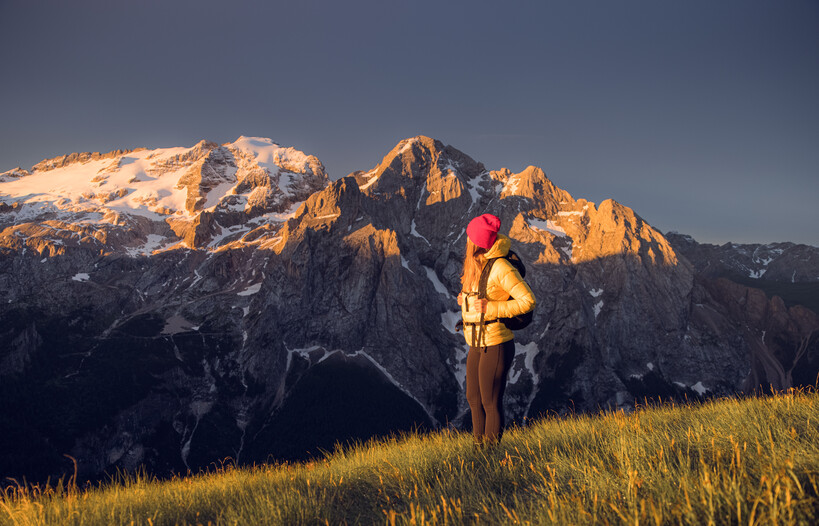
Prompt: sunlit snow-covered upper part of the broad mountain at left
<box><xmin>0</xmin><ymin>137</ymin><xmax>328</xmax><ymax>256</ymax></box>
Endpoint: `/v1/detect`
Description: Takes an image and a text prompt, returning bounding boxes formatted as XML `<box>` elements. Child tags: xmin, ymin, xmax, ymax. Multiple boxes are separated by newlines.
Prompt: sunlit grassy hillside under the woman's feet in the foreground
<box><xmin>0</xmin><ymin>392</ymin><xmax>819</xmax><ymax>525</ymax></box>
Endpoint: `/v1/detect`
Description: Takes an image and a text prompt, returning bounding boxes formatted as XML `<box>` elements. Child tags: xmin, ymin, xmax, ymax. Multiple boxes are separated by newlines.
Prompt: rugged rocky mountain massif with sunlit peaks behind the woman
<box><xmin>0</xmin><ymin>137</ymin><xmax>819</xmax><ymax>486</ymax></box>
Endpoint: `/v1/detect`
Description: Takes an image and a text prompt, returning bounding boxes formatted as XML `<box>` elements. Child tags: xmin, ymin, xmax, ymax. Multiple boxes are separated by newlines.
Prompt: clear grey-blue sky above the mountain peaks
<box><xmin>0</xmin><ymin>0</ymin><xmax>819</xmax><ymax>245</ymax></box>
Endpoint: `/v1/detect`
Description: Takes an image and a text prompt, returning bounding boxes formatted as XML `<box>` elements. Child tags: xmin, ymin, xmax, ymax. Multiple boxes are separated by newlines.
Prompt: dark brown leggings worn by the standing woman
<box><xmin>466</xmin><ymin>340</ymin><xmax>515</xmax><ymax>444</ymax></box>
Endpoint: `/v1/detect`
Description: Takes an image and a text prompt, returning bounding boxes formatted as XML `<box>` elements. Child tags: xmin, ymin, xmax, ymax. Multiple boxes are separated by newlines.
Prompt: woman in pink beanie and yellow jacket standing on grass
<box><xmin>458</xmin><ymin>214</ymin><xmax>535</xmax><ymax>445</ymax></box>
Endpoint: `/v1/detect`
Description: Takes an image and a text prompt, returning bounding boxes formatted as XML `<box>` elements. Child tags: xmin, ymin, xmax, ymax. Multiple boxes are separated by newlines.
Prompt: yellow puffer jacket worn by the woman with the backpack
<box><xmin>461</xmin><ymin>234</ymin><xmax>536</xmax><ymax>347</ymax></box>
